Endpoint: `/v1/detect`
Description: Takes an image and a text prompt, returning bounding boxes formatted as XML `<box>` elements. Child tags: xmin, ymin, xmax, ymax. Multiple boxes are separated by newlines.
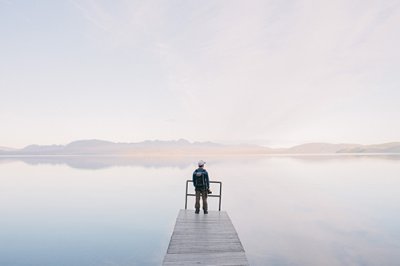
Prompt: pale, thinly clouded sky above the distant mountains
<box><xmin>0</xmin><ymin>0</ymin><xmax>400</xmax><ymax>148</ymax></box>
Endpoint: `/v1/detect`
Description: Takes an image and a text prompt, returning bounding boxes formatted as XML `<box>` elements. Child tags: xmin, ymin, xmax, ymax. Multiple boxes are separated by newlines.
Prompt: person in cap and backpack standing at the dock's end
<box><xmin>193</xmin><ymin>160</ymin><xmax>210</xmax><ymax>214</ymax></box>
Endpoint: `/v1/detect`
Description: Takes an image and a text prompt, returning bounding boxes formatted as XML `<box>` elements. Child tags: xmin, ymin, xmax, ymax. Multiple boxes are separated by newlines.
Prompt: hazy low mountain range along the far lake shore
<box><xmin>0</xmin><ymin>139</ymin><xmax>400</xmax><ymax>155</ymax></box>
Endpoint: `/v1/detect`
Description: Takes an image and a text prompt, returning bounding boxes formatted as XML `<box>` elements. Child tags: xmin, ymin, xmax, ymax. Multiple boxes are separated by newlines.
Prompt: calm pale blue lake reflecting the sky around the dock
<box><xmin>0</xmin><ymin>155</ymin><xmax>400</xmax><ymax>266</ymax></box>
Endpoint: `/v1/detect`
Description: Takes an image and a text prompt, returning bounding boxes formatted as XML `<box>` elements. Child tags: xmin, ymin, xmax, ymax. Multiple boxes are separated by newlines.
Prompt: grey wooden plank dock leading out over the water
<box><xmin>163</xmin><ymin>210</ymin><xmax>249</xmax><ymax>266</ymax></box>
